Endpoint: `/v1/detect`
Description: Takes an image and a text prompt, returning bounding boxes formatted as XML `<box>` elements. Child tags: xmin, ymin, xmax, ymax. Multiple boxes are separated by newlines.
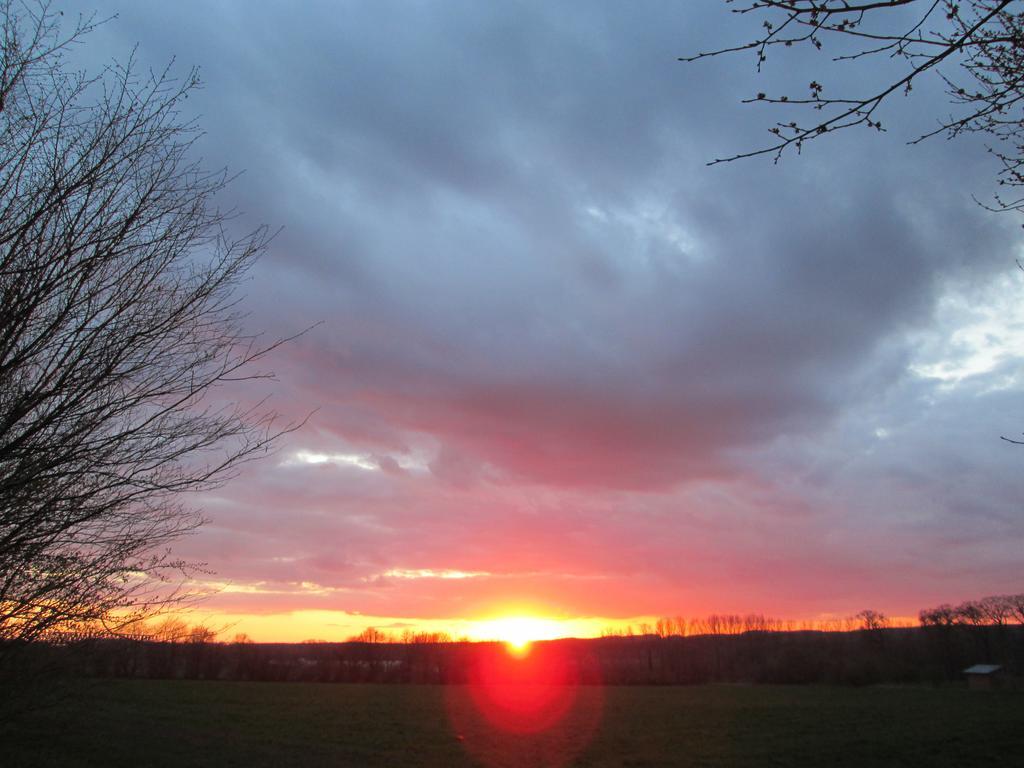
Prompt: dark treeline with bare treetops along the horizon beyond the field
<box><xmin>9</xmin><ymin>595</ymin><xmax>1024</xmax><ymax>685</ymax></box>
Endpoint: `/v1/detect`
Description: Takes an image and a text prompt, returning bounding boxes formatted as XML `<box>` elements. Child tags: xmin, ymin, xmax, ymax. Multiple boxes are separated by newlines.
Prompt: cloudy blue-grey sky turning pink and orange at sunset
<box><xmin>77</xmin><ymin>0</ymin><xmax>1024</xmax><ymax>640</ymax></box>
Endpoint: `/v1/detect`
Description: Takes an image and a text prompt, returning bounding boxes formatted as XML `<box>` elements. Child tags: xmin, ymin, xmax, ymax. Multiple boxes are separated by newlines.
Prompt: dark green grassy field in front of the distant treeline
<box><xmin>0</xmin><ymin>681</ymin><xmax>1024</xmax><ymax>768</ymax></box>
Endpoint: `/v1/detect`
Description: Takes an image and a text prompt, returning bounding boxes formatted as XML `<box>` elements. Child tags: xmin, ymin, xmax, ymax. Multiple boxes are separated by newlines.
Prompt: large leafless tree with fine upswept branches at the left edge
<box><xmin>0</xmin><ymin>0</ymin><xmax>296</xmax><ymax>667</ymax></box>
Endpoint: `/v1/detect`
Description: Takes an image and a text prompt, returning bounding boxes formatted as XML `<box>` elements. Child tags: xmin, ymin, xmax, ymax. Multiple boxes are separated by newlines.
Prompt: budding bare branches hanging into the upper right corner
<box><xmin>681</xmin><ymin>0</ymin><xmax>1024</xmax><ymax>210</ymax></box>
